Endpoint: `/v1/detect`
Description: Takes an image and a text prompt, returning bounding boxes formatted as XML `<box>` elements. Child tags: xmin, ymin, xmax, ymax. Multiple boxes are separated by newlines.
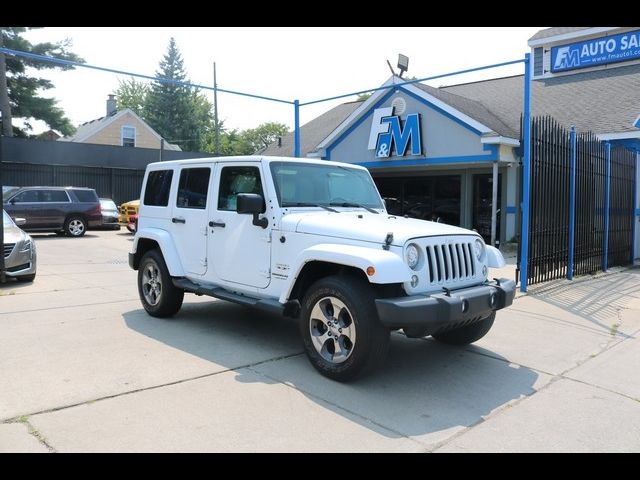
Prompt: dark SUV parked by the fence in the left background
<box><xmin>2</xmin><ymin>187</ymin><xmax>102</xmax><ymax>237</ymax></box>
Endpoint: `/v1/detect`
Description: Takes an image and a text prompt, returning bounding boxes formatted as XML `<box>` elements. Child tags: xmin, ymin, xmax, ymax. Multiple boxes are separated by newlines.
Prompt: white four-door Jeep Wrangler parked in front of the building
<box><xmin>129</xmin><ymin>156</ymin><xmax>515</xmax><ymax>381</ymax></box>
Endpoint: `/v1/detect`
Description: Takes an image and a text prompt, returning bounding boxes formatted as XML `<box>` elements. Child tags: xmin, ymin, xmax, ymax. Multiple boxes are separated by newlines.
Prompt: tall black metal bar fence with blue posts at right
<box><xmin>527</xmin><ymin>117</ymin><xmax>636</xmax><ymax>285</ymax></box>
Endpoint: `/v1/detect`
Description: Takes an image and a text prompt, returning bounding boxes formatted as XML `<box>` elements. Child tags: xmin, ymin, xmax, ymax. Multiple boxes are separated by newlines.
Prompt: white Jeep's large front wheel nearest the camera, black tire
<box><xmin>300</xmin><ymin>275</ymin><xmax>390</xmax><ymax>382</ymax></box>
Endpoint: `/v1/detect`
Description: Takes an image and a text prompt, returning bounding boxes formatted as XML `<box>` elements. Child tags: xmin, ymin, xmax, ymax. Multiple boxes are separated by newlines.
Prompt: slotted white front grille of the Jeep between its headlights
<box><xmin>425</xmin><ymin>242</ymin><xmax>476</xmax><ymax>284</ymax></box>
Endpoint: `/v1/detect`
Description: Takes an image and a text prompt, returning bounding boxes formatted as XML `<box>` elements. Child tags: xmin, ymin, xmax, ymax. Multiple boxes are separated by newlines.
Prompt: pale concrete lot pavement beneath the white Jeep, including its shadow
<box><xmin>0</xmin><ymin>231</ymin><xmax>640</xmax><ymax>452</ymax></box>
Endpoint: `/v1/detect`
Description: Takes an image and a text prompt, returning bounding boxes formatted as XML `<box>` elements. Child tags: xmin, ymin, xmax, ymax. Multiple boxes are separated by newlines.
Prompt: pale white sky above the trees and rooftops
<box><xmin>21</xmin><ymin>27</ymin><xmax>544</xmax><ymax>132</ymax></box>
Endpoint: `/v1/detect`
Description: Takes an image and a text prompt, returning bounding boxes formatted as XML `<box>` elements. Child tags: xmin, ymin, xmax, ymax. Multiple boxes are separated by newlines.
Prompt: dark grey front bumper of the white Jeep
<box><xmin>376</xmin><ymin>278</ymin><xmax>516</xmax><ymax>336</ymax></box>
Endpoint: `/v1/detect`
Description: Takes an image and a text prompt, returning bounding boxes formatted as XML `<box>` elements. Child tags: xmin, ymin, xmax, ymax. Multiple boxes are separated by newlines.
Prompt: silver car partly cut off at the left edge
<box><xmin>2</xmin><ymin>210</ymin><xmax>36</xmax><ymax>282</ymax></box>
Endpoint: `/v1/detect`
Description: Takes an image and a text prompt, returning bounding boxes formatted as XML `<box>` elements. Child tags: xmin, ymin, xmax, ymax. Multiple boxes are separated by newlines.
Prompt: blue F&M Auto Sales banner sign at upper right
<box><xmin>551</xmin><ymin>30</ymin><xmax>640</xmax><ymax>73</ymax></box>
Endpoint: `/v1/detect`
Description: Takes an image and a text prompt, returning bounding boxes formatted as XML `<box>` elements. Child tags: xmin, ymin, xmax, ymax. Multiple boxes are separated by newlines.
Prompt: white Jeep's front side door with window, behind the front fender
<box><xmin>208</xmin><ymin>162</ymin><xmax>271</xmax><ymax>288</ymax></box>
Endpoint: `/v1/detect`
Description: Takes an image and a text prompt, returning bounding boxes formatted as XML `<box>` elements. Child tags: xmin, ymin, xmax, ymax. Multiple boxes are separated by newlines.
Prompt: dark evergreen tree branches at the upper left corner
<box><xmin>0</xmin><ymin>27</ymin><xmax>84</xmax><ymax>136</ymax></box>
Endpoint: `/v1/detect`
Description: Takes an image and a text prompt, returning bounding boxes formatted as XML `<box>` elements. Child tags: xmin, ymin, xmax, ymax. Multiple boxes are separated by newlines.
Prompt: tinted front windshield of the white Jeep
<box><xmin>271</xmin><ymin>162</ymin><xmax>383</xmax><ymax>209</ymax></box>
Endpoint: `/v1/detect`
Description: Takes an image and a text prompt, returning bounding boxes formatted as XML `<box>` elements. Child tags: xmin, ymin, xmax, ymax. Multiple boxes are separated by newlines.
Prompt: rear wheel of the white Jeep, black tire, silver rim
<box><xmin>138</xmin><ymin>249</ymin><xmax>184</xmax><ymax>318</ymax></box>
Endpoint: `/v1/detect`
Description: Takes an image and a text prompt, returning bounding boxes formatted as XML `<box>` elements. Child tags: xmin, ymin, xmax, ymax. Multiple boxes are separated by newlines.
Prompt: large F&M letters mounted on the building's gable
<box><xmin>368</xmin><ymin>107</ymin><xmax>422</xmax><ymax>158</ymax></box>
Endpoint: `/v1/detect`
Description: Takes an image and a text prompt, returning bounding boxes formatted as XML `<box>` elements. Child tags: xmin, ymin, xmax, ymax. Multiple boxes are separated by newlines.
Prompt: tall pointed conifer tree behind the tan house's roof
<box><xmin>143</xmin><ymin>37</ymin><xmax>212</xmax><ymax>150</ymax></box>
